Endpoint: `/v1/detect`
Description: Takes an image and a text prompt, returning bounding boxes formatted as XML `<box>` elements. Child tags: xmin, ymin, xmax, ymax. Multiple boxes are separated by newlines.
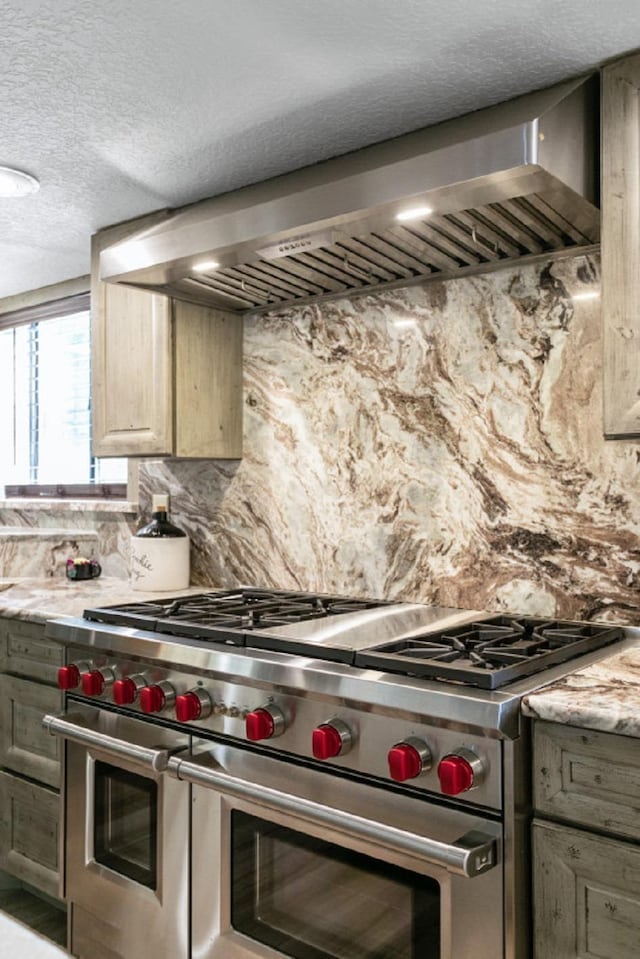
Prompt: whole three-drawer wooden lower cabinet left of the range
<box><xmin>0</xmin><ymin>617</ymin><xmax>63</xmax><ymax>898</ymax></box>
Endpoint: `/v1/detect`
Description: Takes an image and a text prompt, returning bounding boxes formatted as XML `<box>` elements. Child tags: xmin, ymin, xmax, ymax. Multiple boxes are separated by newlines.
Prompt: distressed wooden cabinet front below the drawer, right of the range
<box><xmin>533</xmin><ymin>822</ymin><xmax>640</xmax><ymax>959</ymax></box>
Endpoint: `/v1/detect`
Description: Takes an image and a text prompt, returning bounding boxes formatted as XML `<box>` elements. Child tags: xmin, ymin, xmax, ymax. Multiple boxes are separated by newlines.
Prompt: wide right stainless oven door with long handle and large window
<box><xmin>169</xmin><ymin>742</ymin><xmax>504</xmax><ymax>959</ymax></box>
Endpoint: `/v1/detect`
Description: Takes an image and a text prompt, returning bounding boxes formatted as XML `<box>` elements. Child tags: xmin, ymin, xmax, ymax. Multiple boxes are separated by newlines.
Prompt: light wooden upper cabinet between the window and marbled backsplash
<box><xmin>91</xmin><ymin>214</ymin><xmax>242</xmax><ymax>459</ymax></box>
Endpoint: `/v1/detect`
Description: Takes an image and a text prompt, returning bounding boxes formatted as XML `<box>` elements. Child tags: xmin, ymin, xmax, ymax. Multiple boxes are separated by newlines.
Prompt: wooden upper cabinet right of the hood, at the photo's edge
<box><xmin>602</xmin><ymin>55</ymin><xmax>640</xmax><ymax>439</ymax></box>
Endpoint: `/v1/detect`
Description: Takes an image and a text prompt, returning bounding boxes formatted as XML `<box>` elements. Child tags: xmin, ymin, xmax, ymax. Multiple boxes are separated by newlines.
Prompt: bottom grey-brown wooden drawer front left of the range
<box><xmin>0</xmin><ymin>772</ymin><xmax>60</xmax><ymax>898</ymax></box>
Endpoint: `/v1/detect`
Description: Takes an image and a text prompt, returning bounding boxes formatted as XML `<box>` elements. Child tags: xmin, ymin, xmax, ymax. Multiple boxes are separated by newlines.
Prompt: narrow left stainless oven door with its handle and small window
<box><xmin>44</xmin><ymin>703</ymin><xmax>190</xmax><ymax>959</ymax></box>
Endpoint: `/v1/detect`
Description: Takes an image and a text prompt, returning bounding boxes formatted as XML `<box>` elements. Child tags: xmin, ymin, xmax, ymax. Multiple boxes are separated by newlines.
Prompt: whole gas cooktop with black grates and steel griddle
<box><xmin>84</xmin><ymin>588</ymin><xmax>624</xmax><ymax>689</ymax></box>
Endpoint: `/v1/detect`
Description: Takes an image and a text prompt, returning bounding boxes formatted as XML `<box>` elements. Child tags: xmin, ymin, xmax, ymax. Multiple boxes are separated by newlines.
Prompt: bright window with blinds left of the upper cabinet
<box><xmin>0</xmin><ymin>294</ymin><xmax>127</xmax><ymax>498</ymax></box>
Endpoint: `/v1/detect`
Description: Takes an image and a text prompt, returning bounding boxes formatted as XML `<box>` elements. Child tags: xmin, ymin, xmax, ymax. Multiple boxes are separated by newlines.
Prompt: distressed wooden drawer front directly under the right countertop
<box><xmin>533</xmin><ymin>722</ymin><xmax>640</xmax><ymax>839</ymax></box>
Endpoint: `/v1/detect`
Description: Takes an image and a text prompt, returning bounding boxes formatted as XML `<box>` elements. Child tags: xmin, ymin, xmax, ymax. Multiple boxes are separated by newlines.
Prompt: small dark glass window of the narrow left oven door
<box><xmin>94</xmin><ymin>762</ymin><xmax>158</xmax><ymax>889</ymax></box>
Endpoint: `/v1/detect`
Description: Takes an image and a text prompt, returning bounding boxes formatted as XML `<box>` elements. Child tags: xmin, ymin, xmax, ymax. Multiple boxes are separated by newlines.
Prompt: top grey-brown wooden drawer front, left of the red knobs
<box><xmin>0</xmin><ymin>618</ymin><xmax>63</xmax><ymax>685</ymax></box>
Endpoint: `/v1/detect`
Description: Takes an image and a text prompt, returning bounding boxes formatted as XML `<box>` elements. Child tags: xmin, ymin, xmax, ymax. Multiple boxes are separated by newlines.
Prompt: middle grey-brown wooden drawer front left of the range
<box><xmin>0</xmin><ymin>675</ymin><xmax>63</xmax><ymax>787</ymax></box>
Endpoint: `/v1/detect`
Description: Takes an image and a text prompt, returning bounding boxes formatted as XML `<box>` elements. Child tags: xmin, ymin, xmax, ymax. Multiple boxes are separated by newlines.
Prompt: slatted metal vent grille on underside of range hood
<box><xmin>171</xmin><ymin>194</ymin><xmax>593</xmax><ymax>312</ymax></box>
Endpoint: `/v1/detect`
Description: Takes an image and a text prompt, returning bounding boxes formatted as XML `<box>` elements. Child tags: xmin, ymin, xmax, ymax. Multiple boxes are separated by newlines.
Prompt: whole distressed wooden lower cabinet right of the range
<box><xmin>532</xmin><ymin>722</ymin><xmax>640</xmax><ymax>959</ymax></box>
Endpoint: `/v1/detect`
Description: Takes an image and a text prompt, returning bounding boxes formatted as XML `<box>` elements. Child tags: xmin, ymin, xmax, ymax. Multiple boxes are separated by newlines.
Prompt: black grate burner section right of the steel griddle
<box><xmin>355</xmin><ymin>617</ymin><xmax>623</xmax><ymax>689</ymax></box>
